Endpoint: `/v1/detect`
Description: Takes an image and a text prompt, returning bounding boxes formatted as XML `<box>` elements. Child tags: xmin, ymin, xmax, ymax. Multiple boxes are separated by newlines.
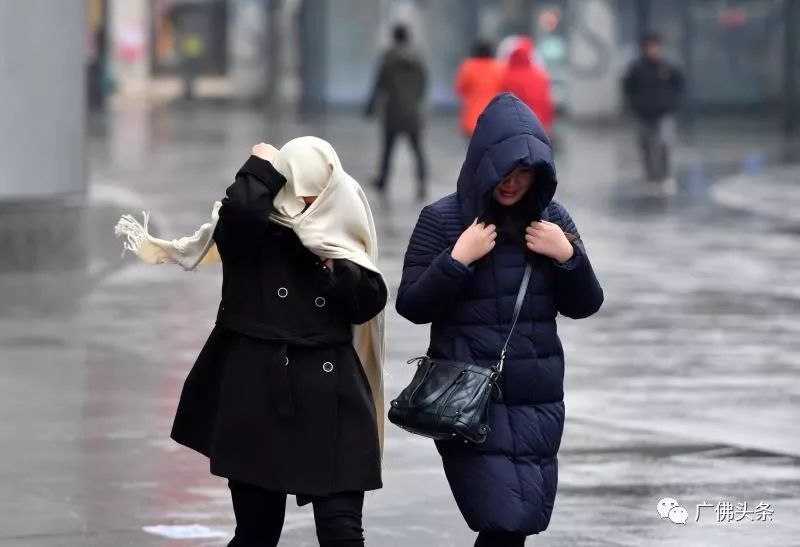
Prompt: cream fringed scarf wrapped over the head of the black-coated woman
<box><xmin>115</xmin><ymin>137</ymin><xmax>385</xmax><ymax>446</ymax></box>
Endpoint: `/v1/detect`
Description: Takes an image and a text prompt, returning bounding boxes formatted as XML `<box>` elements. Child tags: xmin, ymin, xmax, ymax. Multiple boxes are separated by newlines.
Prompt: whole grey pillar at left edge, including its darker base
<box><xmin>0</xmin><ymin>0</ymin><xmax>88</xmax><ymax>272</ymax></box>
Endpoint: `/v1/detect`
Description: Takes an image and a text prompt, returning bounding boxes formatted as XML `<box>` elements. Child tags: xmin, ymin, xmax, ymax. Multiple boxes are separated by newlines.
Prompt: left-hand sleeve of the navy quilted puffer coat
<box><xmin>395</xmin><ymin>206</ymin><xmax>473</xmax><ymax>324</ymax></box>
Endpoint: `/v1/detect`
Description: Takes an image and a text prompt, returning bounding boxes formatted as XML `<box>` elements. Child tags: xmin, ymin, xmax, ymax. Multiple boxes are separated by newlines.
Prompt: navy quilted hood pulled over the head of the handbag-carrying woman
<box><xmin>456</xmin><ymin>93</ymin><xmax>558</xmax><ymax>225</ymax></box>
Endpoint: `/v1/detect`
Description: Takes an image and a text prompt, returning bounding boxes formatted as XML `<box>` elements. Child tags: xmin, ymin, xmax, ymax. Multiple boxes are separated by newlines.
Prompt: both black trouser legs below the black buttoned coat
<box><xmin>228</xmin><ymin>481</ymin><xmax>364</xmax><ymax>547</ymax></box>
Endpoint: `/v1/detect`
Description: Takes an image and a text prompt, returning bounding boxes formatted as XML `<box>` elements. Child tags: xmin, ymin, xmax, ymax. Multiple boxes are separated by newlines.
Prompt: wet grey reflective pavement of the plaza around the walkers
<box><xmin>0</xmin><ymin>106</ymin><xmax>800</xmax><ymax>547</ymax></box>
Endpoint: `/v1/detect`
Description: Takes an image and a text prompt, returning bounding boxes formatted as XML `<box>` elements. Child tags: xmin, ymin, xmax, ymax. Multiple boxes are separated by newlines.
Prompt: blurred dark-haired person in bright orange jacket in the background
<box><xmin>455</xmin><ymin>40</ymin><xmax>505</xmax><ymax>137</ymax></box>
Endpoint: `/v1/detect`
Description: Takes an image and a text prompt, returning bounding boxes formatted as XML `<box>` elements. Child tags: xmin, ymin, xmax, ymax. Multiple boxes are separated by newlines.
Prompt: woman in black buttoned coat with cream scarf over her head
<box><xmin>117</xmin><ymin>137</ymin><xmax>387</xmax><ymax>547</ymax></box>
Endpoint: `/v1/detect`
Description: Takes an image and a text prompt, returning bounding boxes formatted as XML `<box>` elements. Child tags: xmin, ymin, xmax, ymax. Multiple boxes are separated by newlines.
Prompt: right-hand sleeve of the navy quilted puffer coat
<box><xmin>551</xmin><ymin>204</ymin><xmax>604</xmax><ymax>319</ymax></box>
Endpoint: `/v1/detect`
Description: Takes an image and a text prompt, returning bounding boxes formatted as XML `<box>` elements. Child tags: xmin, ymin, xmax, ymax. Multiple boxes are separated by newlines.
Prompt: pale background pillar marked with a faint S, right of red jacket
<box><xmin>566</xmin><ymin>0</ymin><xmax>621</xmax><ymax>120</ymax></box>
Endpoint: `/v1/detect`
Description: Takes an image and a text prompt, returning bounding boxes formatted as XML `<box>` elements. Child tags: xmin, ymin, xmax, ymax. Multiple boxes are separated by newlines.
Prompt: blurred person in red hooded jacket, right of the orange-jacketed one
<box><xmin>502</xmin><ymin>38</ymin><xmax>555</xmax><ymax>135</ymax></box>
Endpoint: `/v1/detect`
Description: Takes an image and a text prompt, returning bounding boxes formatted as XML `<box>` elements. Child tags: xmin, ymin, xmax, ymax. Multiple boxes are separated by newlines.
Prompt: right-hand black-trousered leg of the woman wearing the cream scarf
<box><xmin>314</xmin><ymin>492</ymin><xmax>364</xmax><ymax>547</ymax></box>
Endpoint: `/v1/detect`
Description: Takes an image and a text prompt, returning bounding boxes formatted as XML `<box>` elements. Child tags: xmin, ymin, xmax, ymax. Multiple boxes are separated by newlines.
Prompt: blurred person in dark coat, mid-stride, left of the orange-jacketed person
<box><xmin>366</xmin><ymin>25</ymin><xmax>428</xmax><ymax>201</ymax></box>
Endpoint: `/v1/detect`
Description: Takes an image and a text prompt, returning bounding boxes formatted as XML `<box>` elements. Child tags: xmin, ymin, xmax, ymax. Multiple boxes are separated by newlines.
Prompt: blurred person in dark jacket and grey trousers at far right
<box><xmin>623</xmin><ymin>33</ymin><xmax>684</xmax><ymax>194</ymax></box>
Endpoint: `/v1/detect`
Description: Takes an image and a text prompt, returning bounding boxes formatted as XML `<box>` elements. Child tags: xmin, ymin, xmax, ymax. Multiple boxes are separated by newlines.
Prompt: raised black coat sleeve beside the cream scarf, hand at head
<box><xmin>214</xmin><ymin>156</ymin><xmax>286</xmax><ymax>257</ymax></box>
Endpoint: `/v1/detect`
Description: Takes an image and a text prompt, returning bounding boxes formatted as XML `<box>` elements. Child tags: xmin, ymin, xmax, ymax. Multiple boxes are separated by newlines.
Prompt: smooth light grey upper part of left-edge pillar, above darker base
<box><xmin>0</xmin><ymin>0</ymin><xmax>87</xmax><ymax>201</ymax></box>
